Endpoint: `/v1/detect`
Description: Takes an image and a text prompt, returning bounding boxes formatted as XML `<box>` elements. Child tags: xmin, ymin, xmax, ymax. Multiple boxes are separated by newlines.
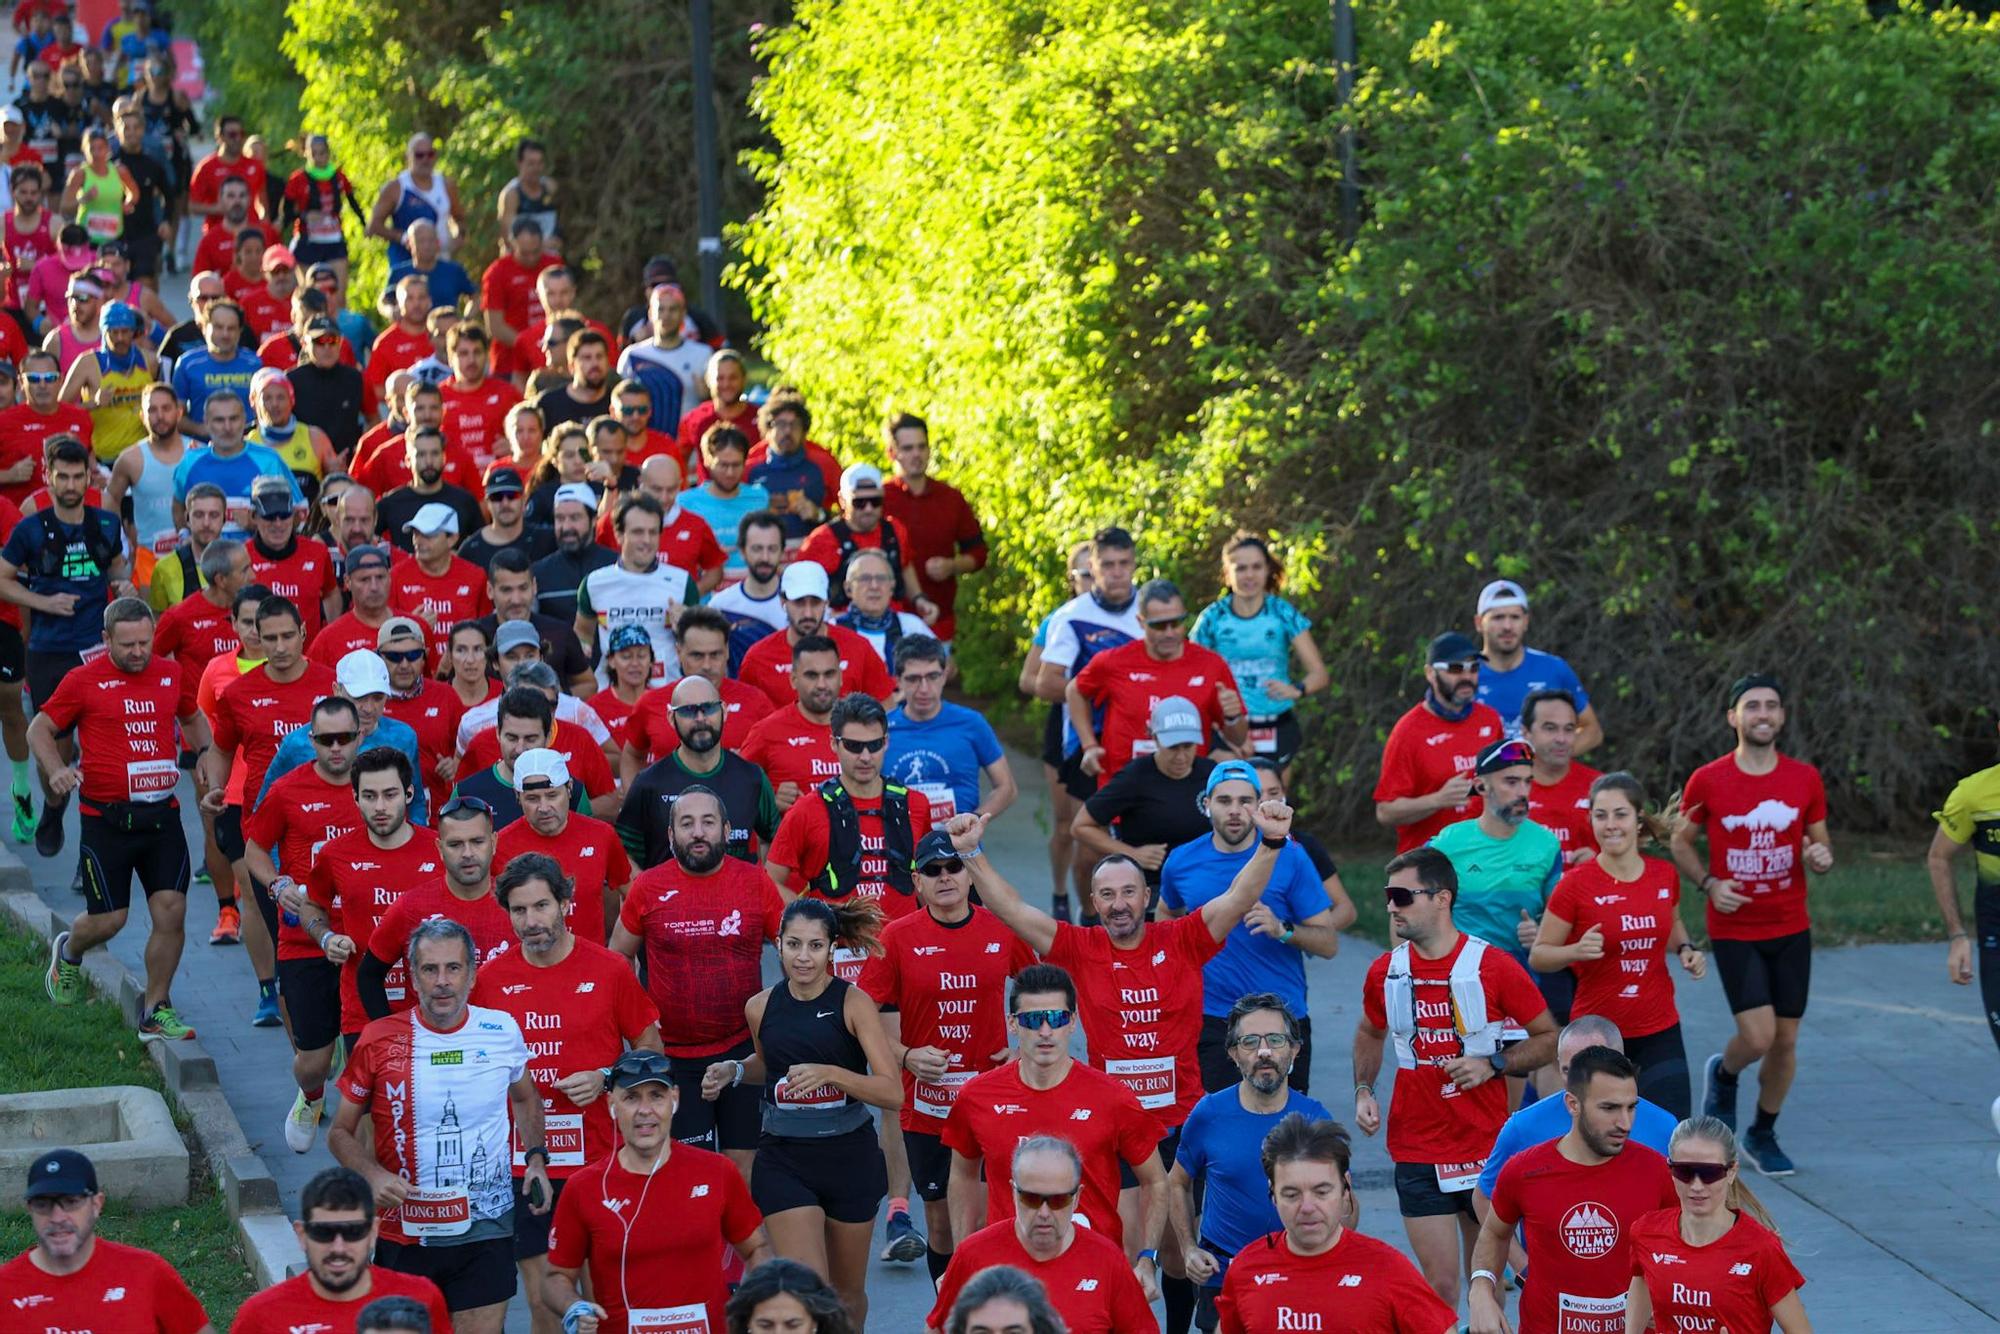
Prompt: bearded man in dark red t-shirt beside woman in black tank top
<box><xmin>612</xmin><ymin>788</ymin><xmax>784</xmax><ymax>1180</ymax></box>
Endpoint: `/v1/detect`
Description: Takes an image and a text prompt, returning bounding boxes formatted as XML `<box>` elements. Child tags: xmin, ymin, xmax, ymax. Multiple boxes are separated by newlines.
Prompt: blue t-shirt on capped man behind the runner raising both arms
<box><xmin>1160</xmin><ymin>838</ymin><xmax>1334</xmax><ymax>1018</ymax></box>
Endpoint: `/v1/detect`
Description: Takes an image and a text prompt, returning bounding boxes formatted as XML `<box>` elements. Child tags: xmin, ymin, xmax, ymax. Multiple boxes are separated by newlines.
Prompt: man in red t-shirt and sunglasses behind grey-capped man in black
<box><xmin>1064</xmin><ymin>580</ymin><xmax>1250</xmax><ymax>788</ymax></box>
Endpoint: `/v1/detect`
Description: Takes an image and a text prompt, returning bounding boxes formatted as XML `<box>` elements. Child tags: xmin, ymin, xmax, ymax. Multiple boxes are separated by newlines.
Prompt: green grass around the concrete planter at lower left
<box><xmin>0</xmin><ymin>924</ymin><xmax>254</xmax><ymax>1330</ymax></box>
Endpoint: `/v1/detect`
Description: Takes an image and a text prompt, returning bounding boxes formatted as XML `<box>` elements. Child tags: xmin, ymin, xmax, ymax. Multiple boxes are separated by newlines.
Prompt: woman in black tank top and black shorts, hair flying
<box><xmin>744</xmin><ymin>898</ymin><xmax>902</xmax><ymax>1328</ymax></box>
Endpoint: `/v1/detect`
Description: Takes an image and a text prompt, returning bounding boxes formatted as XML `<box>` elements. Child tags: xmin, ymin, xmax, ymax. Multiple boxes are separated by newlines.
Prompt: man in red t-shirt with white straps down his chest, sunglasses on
<box><xmin>1354</xmin><ymin>846</ymin><xmax>1556</xmax><ymax>1310</ymax></box>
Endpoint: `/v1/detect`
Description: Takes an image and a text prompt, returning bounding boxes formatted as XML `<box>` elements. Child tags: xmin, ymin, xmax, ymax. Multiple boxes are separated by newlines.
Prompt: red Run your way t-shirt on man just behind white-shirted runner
<box><xmin>472</xmin><ymin>936</ymin><xmax>660</xmax><ymax>1180</ymax></box>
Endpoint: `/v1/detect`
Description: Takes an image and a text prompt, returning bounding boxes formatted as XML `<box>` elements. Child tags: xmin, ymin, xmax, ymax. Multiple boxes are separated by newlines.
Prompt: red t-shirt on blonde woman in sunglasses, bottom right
<box><xmin>1632</xmin><ymin>1208</ymin><xmax>1806</xmax><ymax>1334</ymax></box>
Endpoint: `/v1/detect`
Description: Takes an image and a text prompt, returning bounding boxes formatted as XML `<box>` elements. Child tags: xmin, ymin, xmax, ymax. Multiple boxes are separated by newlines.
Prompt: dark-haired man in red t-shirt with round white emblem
<box><xmin>1470</xmin><ymin>1046</ymin><xmax>1680</xmax><ymax>1334</ymax></box>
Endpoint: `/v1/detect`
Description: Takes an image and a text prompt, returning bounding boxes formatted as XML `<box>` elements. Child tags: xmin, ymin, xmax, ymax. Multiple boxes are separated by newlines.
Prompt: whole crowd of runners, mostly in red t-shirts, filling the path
<box><xmin>0</xmin><ymin>0</ymin><xmax>2000</xmax><ymax>1334</ymax></box>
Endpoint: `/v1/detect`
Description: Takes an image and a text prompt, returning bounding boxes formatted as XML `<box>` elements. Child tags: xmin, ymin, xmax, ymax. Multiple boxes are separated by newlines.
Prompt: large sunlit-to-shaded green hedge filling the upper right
<box><xmin>738</xmin><ymin>0</ymin><xmax>2000</xmax><ymax>826</ymax></box>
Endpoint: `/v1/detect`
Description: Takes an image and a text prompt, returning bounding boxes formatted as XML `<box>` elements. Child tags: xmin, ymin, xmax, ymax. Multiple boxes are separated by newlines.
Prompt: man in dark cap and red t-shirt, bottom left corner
<box><xmin>0</xmin><ymin>1148</ymin><xmax>216</xmax><ymax>1334</ymax></box>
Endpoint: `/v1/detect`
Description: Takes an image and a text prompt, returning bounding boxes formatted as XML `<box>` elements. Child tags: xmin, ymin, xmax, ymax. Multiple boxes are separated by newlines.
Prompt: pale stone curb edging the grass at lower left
<box><xmin>0</xmin><ymin>844</ymin><xmax>306</xmax><ymax>1288</ymax></box>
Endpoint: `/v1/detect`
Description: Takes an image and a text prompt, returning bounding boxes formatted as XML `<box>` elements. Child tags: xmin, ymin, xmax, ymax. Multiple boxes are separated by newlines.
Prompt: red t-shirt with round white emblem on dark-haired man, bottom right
<box><xmin>1492</xmin><ymin>1140</ymin><xmax>1680</xmax><ymax>1334</ymax></box>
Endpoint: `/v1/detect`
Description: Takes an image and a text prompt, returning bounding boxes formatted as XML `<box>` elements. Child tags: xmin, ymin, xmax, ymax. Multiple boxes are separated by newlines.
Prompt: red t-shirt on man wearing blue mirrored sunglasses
<box><xmin>938</xmin><ymin>1062</ymin><xmax>1166</xmax><ymax>1246</ymax></box>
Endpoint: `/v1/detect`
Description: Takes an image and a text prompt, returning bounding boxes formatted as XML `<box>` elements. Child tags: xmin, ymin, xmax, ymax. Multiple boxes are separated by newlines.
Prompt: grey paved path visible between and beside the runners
<box><xmin>22</xmin><ymin>740</ymin><xmax>2000</xmax><ymax>1334</ymax></box>
